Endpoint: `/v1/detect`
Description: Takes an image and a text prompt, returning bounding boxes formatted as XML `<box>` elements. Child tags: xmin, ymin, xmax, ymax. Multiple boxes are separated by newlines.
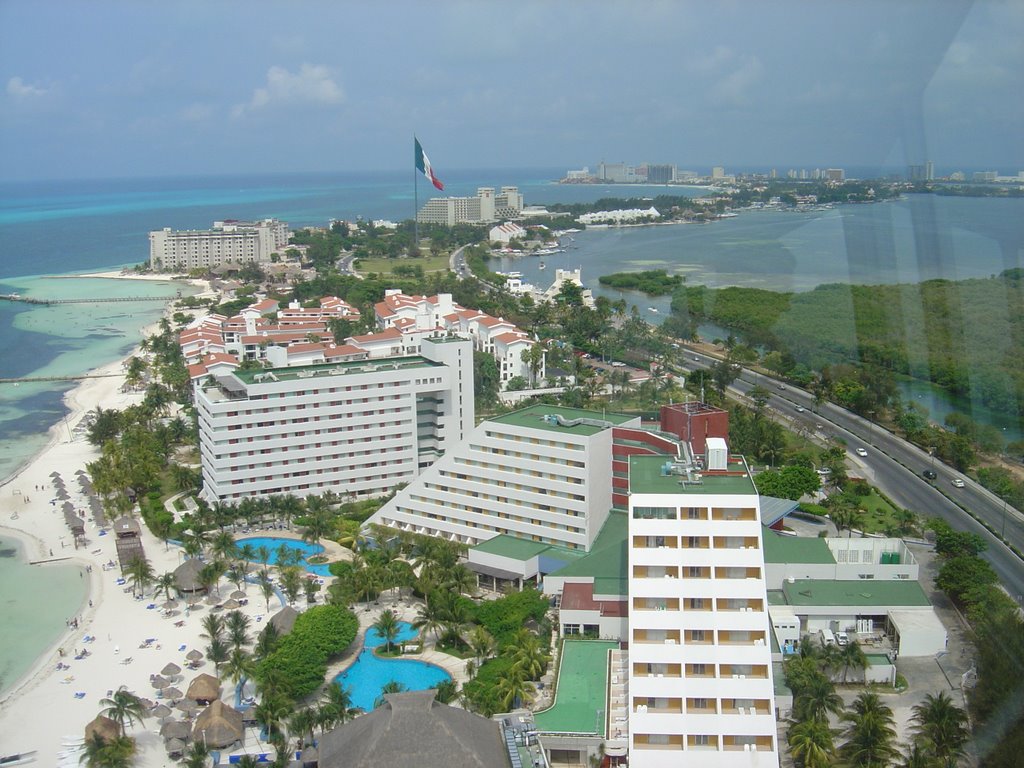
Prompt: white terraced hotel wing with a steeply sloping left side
<box><xmin>370</xmin><ymin>406</ymin><xmax>640</xmax><ymax>550</ymax></box>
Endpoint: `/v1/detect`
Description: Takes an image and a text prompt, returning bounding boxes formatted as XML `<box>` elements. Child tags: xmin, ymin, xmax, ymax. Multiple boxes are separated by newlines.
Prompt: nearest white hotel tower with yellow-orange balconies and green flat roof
<box><xmin>628</xmin><ymin>448</ymin><xmax>778</xmax><ymax>768</ymax></box>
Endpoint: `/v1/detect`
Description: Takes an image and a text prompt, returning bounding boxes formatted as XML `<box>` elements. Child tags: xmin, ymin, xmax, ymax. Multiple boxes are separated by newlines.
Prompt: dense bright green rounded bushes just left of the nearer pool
<box><xmin>256</xmin><ymin>605</ymin><xmax>359</xmax><ymax>700</ymax></box>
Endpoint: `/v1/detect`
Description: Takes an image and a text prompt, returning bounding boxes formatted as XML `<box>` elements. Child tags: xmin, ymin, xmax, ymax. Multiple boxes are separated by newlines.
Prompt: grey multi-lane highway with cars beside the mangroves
<box><xmin>685</xmin><ymin>349</ymin><xmax>1024</xmax><ymax>602</ymax></box>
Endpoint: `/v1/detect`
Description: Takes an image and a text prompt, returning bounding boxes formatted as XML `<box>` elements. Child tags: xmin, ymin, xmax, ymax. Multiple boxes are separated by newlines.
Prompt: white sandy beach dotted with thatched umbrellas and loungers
<box><xmin>0</xmin><ymin>273</ymin><xmax>465</xmax><ymax>768</ymax></box>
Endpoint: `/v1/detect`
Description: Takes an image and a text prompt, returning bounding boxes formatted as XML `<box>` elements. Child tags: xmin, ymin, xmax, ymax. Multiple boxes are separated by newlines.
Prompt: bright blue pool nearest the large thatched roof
<box><xmin>334</xmin><ymin>622</ymin><xmax>452</xmax><ymax>712</ymax></box>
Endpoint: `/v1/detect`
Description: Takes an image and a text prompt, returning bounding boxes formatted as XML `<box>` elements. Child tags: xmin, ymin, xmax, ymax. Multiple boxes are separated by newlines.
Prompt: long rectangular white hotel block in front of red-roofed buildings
<box><xmin>196</xmin><ymin>335</ymin><xmax>474</xmax><ymax>503</ymax></box>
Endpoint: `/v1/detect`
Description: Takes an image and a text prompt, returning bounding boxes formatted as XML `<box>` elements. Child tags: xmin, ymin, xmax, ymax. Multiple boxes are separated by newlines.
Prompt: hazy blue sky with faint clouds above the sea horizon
<box><xmin>0</xmin><ymin>0</ymin><xmax>1024</xmax><ymax>180</ymax></box>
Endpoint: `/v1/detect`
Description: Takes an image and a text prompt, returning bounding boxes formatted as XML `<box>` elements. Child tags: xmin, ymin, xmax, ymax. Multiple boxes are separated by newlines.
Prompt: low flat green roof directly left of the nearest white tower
<box><xmin>534</xmin><ymin>640</ymin><xmax>618</xmax><ymax>735</ymax></box>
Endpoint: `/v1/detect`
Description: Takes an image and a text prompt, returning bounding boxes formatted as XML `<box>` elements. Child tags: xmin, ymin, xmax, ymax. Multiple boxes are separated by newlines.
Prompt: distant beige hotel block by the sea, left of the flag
<box><xmin>150</xmin><ymin>219</ymin><xmax>290</xmax><ymax>270</ymax></box>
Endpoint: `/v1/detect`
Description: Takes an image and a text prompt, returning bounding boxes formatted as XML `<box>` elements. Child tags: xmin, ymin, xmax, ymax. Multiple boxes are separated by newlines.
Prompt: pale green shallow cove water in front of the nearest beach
<box><xmin>0</xmin><ymin>536</ymin><xmax>88</xmax><ymax>694</ymax></box>
